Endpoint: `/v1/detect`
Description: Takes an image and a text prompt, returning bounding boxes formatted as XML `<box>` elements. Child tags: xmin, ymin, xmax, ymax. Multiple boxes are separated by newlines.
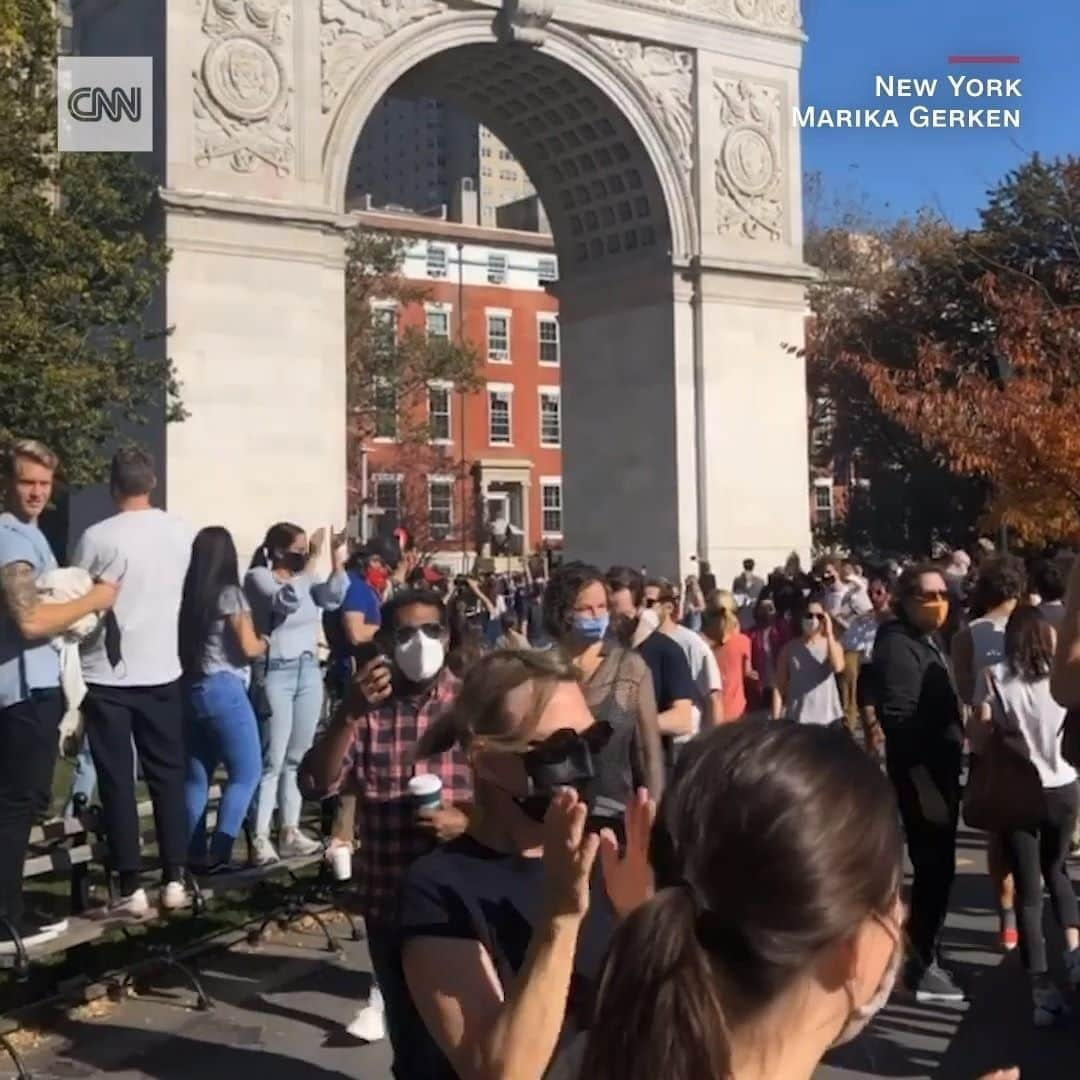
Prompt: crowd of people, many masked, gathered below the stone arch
<box><xmin>0</xmin><ymin>432</ymin><xmax>1080</xmax><ymax>1080</ymax></box>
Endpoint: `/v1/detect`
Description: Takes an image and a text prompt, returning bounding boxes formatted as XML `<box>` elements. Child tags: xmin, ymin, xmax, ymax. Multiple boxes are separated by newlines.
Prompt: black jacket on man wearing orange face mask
<box><xmin>873</xmin><ymin>618</ymin><xmax>963</xmax><ymax>759</ymax></box>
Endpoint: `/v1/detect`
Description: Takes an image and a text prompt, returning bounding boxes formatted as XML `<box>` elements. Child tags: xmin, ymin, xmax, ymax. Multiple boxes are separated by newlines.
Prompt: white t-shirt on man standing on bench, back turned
<box><xmin>73</xmin><ymin>510</ymin><xmax>193</xmax><ymax>687</ymax></box>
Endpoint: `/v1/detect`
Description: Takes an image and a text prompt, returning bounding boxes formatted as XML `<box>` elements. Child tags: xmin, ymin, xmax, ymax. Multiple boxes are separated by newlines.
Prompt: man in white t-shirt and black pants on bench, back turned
<box><xmin>75</xmin><ymin>449</ymin><xmax>192</xmax><ymax>916</ymax></box>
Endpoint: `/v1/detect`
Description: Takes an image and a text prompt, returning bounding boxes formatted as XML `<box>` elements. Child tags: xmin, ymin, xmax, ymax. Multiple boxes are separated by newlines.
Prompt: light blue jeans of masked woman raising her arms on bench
<box><xmin>255</xmin><ymin>652</ymin><xmax>323</xmax><ymax>836</ymax></box>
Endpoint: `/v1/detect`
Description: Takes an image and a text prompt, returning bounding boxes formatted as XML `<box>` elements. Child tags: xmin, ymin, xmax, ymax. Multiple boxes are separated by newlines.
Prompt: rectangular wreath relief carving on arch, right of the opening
<box><xmin>713</xmin><ymin>76</ymin><xmax>784</xmax><ymax>242</ymax></box>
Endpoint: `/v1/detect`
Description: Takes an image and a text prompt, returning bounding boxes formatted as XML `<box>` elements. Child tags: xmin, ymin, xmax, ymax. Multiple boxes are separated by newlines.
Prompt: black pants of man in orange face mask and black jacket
<box><xmin>886</xmin><ymin>742</ymin><xmax>962</xmax><ymax>964</ymax></box>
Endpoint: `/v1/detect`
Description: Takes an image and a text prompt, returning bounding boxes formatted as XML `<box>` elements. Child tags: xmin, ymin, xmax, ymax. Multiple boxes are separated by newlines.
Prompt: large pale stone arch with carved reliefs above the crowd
<box><xmin>73</xmin><ymin>0</ymin><xmax>810</xmax><ymax>581</ymax></box>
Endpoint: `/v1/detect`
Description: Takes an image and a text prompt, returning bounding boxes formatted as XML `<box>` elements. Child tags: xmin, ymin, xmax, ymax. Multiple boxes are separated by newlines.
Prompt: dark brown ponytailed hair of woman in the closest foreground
<box><xmin>580</xmin><ymin>719</ymin><xmax>902</xmax><ymax>1080</ymax></box>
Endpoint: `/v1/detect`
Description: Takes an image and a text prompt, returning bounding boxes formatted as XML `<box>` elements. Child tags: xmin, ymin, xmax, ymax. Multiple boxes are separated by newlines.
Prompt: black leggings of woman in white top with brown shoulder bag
<box><xmin>1004</xmin><ymin>783</ymin><xmax>1080</xmax><ymax>975</ymax></box>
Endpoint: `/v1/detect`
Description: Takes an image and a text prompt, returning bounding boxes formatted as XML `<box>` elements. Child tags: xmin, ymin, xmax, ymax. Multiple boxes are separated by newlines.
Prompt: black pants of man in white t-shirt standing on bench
<box><xmin>83</xmin><ymin>683</ymin><xmax>188</xmax><ymax>880</ymax></box>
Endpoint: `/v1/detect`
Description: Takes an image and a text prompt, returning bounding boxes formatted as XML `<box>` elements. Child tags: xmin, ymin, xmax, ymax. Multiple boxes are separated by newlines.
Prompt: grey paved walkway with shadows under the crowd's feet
<box><xmin>8</xmin><ymin>837</ymin><xmax>1080</xmax><ymax>1080</ymax></box>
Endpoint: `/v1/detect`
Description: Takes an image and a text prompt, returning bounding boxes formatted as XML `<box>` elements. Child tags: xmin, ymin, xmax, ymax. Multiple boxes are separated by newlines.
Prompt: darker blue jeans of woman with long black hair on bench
<box><xmin>184</xmin><ymin>672</ymin><xmax>262</xmax><ymax>863</ymax></box>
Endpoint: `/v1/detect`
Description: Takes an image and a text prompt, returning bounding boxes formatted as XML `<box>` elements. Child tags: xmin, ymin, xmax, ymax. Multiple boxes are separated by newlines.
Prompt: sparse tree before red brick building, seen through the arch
<box><xmin>346</xmin><ymin>229</ymin><xmax>482</xmax><ymax>514</ymax></box>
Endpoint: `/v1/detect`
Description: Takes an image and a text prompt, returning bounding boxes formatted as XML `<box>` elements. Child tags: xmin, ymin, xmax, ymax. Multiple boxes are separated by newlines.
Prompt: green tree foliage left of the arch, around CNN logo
<box><xmin>0</xmin><ymin>0</ymin><xmax>183</xmax><ymax>484</ymax></box>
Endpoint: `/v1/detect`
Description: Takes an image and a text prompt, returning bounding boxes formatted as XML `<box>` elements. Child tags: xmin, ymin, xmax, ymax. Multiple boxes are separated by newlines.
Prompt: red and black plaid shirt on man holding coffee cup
<box><xmin>327</xmin><ymin>671</ymin><xmax>472</xmax><ymax>922</ymax></box>
